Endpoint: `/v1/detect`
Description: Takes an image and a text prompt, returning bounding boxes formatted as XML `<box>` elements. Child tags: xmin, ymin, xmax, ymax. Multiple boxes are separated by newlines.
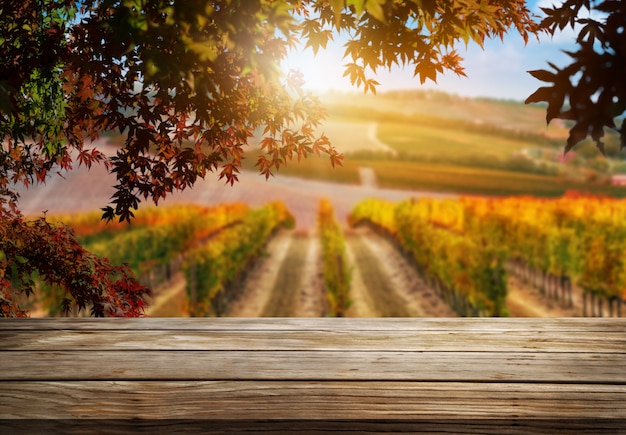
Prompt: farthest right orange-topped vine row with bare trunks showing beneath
<box><xmin>463</xmin><ymin>194</ymin><xmax>626</xmax><ymax>315</ymax></box>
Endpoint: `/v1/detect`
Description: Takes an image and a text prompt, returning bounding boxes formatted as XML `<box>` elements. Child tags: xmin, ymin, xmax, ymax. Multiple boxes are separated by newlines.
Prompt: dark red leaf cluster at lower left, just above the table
<box><xmin>0</xmin><ymin>217</ymin><xmax>149</xmax><ymax>317</ymax></box>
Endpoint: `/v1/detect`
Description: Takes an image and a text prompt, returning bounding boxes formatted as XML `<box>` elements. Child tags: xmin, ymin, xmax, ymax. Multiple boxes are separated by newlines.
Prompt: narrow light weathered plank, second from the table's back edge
<box><xmin>0</xmin><ymin>329</ymin><xmax>626</xmax><ymax>354</ymax></box>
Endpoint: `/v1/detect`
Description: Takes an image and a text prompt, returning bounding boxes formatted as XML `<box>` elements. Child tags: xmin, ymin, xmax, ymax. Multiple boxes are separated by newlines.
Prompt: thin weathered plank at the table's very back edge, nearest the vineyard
<box><xmin>0</xmin><ymin>317</ymin><xmax>626</xmax><ymax>333</ymax></box>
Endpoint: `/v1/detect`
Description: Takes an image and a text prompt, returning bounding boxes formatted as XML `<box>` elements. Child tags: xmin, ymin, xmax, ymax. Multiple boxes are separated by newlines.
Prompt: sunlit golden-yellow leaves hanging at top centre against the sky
<box><xmin>300</xmin><ymin>0</ymin><xmax>538</xmax><ymax>92</ymax></box>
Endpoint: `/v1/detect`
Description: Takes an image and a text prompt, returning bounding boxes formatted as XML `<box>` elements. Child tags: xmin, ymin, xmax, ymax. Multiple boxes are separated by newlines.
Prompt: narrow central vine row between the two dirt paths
<box><xmin>318</xmin><ymin>199</ymin><xmax>352</xmax><ymax>317</ymax></box>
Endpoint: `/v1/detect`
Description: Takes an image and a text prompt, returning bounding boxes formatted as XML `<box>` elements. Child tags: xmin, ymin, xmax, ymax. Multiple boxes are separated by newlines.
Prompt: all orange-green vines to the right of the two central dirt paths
<box><xmin>351</xmin><ymin>195</ymin><xmax>626</xmax><ymax>316</ymax></box>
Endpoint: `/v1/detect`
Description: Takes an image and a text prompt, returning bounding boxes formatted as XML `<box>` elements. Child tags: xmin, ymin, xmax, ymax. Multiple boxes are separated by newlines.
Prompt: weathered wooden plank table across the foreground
<box><xmin>0</xmin><ymin>318</ymin><xmax>626</xmax><ymax>434</ymax></box>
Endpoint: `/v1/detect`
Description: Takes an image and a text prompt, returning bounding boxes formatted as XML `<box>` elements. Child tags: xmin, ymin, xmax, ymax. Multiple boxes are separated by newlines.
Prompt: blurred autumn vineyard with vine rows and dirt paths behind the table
<box><xmin>26</xmin><ymin>195</ymin><xmax>626</xmax><ymax>317</ymax></box>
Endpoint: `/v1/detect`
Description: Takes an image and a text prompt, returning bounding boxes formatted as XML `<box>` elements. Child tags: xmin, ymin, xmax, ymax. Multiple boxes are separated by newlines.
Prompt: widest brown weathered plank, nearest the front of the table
<box><xmin>0</xmin><ymin>381</ymin><xmax>626</xmax><ymax>421</ymax></box>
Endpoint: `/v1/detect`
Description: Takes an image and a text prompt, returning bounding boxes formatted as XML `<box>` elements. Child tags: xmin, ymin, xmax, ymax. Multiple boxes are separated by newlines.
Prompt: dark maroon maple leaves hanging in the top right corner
<box><xmin>526</xmin><ymin>0</ymin><xmax>626</xmax><ymax>154</ymax></box>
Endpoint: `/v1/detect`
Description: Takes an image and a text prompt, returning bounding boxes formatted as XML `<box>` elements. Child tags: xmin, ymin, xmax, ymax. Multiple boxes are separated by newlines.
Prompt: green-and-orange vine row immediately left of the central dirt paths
<box><xmin>185</xmin><ymin>202</ymin><xmax>294</xmax><ymax>316</ymax></box>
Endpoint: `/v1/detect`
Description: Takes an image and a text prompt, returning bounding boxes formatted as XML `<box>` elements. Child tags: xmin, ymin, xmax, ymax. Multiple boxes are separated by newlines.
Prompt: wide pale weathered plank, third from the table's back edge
<box><xmin>0</xmin><ymin>351</ymin><xmax>626</xmax><ymax>385</ymax></box>
